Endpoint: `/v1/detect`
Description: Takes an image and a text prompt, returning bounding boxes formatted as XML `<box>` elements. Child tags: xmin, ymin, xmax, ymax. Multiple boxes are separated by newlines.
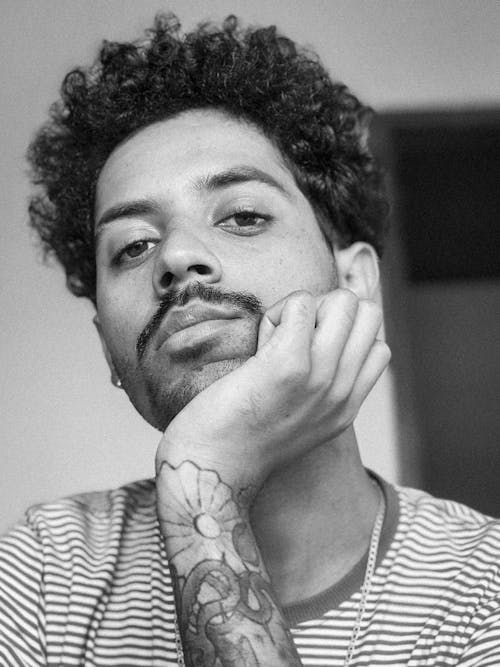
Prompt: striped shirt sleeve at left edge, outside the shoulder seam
<box><xmin>0</xmin><ymin>525</ymin><xmax>46</xmax><ymax>667</ymax></box>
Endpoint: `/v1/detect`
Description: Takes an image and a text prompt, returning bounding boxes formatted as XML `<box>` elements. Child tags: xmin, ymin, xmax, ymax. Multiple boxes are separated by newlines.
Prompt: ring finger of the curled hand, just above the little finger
<box><xmin>334</xmin><ymin>299</ymin><xmax>382</xmax><ymax>392</ymax></box>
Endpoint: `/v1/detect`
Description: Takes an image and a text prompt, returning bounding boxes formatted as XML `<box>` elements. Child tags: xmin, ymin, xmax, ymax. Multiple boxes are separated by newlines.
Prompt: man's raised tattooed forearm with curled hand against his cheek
<box><xmin>157</xmin><ymin>289</ymin><xmax>390</xmax><ymax>667</ymax></box>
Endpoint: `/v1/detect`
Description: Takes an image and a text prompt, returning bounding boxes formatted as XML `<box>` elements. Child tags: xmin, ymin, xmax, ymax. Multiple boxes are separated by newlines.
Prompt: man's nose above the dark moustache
<box><xmin>153</xmin><ymin>229</ymin><xmax>222</xmax><ymax>298</ymax></box>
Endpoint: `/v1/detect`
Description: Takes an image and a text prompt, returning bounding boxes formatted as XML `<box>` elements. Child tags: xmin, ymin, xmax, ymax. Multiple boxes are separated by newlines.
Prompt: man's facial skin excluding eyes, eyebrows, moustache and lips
<box><xmin>96</xmin><ymin>112</ymin><xmax>336</xmax><ymax>422</ymax></box>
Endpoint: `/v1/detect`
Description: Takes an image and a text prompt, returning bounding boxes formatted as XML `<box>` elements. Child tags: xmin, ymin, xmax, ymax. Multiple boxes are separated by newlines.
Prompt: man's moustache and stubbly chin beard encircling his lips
<box><xmin>133</xmin><ymin>283</ymin><xmax>264</xmax><ymax>431</ymax></box>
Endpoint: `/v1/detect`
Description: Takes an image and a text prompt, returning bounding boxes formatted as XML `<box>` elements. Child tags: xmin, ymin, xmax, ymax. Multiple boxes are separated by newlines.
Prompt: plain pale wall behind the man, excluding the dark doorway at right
<box><xmin>0</xmin><ymin>0</ymin><xmax>500</xmax><ymax>531</ymax></box>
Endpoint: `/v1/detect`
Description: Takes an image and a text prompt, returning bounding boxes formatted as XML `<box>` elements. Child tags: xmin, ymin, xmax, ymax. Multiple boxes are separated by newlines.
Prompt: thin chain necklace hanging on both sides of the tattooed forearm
<box><xmin>174</xmin><ymin>481</ymin><xmax>385</xmax><ymax>667</ymax></box>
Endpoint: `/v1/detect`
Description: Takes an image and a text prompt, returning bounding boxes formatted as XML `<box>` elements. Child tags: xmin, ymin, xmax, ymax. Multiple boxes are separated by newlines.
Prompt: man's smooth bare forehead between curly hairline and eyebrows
<box><xmin>95</xmin><ymin>110</ymin><xmax>294</xmax><ymax>218</ymax></box>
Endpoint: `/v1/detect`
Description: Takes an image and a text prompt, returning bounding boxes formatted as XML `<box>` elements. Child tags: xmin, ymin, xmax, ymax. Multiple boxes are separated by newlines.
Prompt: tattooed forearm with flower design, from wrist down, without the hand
<box><xmin>157</xmin><ymin>459</ymin><xmax>301</xmax><ymax>667</ymax></box>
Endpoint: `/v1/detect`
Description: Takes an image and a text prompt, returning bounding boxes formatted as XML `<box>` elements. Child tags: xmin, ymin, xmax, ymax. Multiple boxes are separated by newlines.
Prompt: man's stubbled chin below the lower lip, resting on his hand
<box><xmin>142</xmin><ymin>358</ymin><xmax>246</xmax><ymax>432</ymax></box>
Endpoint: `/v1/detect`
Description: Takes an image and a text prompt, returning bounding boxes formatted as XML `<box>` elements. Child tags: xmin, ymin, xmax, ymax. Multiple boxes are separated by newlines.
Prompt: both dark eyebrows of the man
<box><xmin>95</xmin><ymin>166</ymin><xmax>291</xmax><ymax>237</ymax></box>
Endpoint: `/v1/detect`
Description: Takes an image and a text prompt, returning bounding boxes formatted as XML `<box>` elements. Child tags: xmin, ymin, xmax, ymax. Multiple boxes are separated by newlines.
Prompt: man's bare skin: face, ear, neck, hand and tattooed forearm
<box><xmin>96</xmin><ymin>111</ymin><xmax>389</xmax><ymax>665</ymax></box>
